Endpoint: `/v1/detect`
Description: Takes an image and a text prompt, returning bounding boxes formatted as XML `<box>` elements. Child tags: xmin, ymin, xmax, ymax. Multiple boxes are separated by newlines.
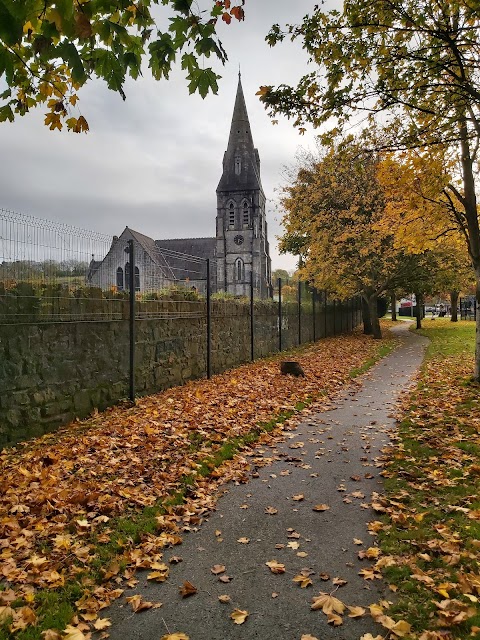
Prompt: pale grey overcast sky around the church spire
<box><xmin>0</xmin><ymin>0</ymin><xmax>328</xmax><ymax>269</ymax></box>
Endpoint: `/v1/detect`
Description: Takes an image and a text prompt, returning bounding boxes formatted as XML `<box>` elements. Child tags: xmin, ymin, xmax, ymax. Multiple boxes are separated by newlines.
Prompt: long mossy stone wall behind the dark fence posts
<box><xmin>0</xmin><ymin>300</ymin><xmax>361</xmax><ymax>445</ymax></box>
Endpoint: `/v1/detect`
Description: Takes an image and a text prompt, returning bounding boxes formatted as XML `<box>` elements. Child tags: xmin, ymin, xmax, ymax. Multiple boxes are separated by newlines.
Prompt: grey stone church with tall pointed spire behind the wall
<box><xmin>87</xmin><ymin>74</ymin><xmax>272</xmax><ymax>298</ymax></box>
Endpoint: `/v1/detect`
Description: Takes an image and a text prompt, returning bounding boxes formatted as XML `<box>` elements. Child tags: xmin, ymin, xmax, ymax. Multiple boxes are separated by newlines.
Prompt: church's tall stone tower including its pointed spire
<box><xmin>216</xmin><ymin>73</ymin><xmax>272</xmax><ymax>298</ymax></box>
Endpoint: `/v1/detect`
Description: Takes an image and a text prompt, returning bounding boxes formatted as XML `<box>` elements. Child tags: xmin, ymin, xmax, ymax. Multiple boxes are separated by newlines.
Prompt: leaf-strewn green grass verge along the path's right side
<box><xmin>375</xmin><ymin>319</ymin><xmax>480</xmax><ymax>640</ymax></box>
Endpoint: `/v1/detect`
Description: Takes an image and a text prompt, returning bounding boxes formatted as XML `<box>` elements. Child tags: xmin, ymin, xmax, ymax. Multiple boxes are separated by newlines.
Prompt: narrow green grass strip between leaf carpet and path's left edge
<box><xmin>0</xmin><ymin>341</ymin><xmax>394</xmax><ymax>640</ymax></box>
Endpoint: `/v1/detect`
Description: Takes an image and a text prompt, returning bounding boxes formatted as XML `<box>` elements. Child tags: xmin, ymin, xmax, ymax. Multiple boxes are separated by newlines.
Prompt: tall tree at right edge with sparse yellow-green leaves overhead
<box><xmin>259</xmin><ymin>0</ymin><xmax>480</xmax><ymax>380</ymax></box>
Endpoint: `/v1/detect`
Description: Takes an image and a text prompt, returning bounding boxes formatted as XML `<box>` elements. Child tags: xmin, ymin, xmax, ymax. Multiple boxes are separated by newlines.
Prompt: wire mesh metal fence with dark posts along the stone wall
<box><xmin>0</xmin><ymin>209</ymin><xmax>360</xmax><ymax>400</ymax></box>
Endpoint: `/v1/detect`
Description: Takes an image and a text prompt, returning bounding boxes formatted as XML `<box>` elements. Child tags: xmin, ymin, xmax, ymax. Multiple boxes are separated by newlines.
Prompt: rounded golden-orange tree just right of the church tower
<box><xmin>280</xmin><ymin>137</ymin><xmax>409</xmax><ymax>338</ymax></box>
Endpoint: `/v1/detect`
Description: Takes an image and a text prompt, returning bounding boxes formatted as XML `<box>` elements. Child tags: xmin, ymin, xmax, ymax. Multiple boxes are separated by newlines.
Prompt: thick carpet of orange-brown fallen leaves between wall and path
<box><xmin>0</xmin><ymin>335</ymin><xmax>377</xmax><ymax>640</ymax></box>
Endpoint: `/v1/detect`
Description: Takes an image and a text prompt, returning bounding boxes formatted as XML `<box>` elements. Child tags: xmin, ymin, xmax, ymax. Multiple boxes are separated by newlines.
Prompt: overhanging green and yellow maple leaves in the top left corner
<box><xmin>0</xmin><ymin>0</ymin><xmax>244</xmax><ymax>132</ymax></box>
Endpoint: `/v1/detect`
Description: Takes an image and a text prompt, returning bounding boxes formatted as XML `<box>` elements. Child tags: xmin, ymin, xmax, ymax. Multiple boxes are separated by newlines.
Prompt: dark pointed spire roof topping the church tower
<box><xmin>217</xmin><ymin>74</ymin><xmax>262</xmax><ymax>192</ymax></box>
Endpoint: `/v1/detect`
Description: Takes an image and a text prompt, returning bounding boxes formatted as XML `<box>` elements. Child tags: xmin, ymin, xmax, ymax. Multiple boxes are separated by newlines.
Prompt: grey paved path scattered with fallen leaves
<box><xmin>102</xmin><ymin>323</ymin><xmax>426</xmax><ymax>640</ymax></box>
